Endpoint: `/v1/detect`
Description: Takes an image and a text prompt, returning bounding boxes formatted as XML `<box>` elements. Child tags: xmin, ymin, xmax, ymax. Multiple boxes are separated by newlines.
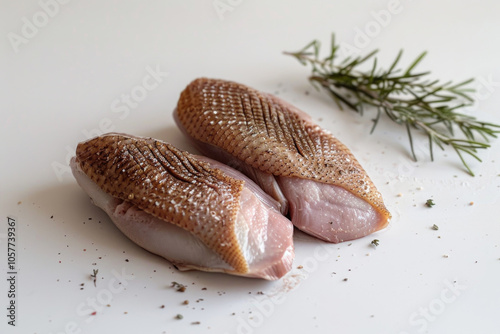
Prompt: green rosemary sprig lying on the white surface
<box><xmin>285</xmin><ymin>35</ymin><xmax>500</xmax><ymax>175</ymax></box>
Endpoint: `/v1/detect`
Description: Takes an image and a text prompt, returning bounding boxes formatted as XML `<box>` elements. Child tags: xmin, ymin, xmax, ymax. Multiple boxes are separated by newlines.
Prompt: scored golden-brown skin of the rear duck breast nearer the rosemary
<box><xmin>176</xmin><ymin>78</ymin><xmax>391</xmax><ymax>229</ymax></box>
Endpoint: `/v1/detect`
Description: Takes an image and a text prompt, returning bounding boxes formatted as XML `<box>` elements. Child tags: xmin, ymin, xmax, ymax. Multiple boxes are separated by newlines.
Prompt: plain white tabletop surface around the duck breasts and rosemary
<box><xmin>0</xmin><ymin>0</ymin><xmax>500</xmax><ymax>334</ymax></box>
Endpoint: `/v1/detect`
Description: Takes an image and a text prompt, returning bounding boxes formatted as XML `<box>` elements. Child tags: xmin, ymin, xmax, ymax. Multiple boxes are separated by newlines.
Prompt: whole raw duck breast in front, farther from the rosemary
<box><xmin>71</xmin><ymin>133</ymin><xmax>294</xmax><ymax>280</ymax></box>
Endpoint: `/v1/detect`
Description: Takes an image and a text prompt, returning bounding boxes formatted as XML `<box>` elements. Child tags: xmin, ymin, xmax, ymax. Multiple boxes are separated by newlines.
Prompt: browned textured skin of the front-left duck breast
<box><xmin>76</xmin><ymin>134</ymin><xmax>248</xmax><ymax>274</ymax></box>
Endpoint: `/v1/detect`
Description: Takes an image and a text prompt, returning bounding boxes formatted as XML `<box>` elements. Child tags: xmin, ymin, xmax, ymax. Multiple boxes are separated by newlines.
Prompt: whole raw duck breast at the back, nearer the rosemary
<box><xmin>174</xmin><ymin>78</ymin><xmax>390</xmax><ymax>243</ymax></box>
